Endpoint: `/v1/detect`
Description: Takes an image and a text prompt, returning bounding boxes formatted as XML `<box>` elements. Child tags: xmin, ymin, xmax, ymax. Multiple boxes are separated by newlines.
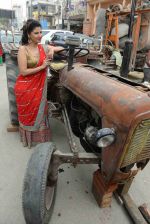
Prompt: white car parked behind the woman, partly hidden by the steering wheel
<box><xmin>41</xmin><ymin>30</ymin><xmax>73</xmax><ymax>44</ymax></box>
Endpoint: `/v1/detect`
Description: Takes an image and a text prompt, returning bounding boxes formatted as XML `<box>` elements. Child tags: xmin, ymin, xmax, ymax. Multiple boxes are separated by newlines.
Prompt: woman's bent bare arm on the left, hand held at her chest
<box><xmin>18</xmin><ymin>46</ymin><xmax>47</xmax><ymax>76</ymax></box>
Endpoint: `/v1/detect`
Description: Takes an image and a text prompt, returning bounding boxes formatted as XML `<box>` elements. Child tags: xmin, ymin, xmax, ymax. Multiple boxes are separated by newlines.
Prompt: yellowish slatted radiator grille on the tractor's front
<box><xmin>121</xmin><ymin>120</ymin><xmax>150</xmax><ymax>167</ymax></box>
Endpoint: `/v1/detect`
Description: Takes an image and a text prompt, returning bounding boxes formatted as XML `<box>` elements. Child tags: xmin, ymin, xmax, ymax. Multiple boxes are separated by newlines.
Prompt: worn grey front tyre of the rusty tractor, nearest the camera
<box><xmin>22</xmin><ymin>142</ymin><xmax>57</xmax><ymax>224</ymax></box>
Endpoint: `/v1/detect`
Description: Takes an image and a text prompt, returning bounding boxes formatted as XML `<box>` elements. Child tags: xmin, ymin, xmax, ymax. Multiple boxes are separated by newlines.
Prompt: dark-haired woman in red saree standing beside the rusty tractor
<box><xmin>15</xmin><ymin>20</ymin><xmax>62</xmax><ymax>148</ymax></box>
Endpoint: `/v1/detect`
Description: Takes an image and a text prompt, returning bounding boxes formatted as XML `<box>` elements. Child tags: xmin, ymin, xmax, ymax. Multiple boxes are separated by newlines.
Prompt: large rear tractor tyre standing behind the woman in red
<box><xmin>6</xmin><ymin>54</ymin><xmax>19</xmax><ymax>125</ymax></box>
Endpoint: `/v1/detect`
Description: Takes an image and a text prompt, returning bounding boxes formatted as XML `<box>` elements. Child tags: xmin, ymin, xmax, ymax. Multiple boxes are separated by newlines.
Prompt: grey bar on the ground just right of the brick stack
<box><xmin>121</xmin><ymin>194</ymin><xmax>147</xmax><ymax>224</ymax></box>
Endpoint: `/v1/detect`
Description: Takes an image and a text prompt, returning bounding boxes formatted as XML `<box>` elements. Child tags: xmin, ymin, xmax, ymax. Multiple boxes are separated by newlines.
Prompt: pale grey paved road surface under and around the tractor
<box><xmin>0</xmin><ymin>65</ymin><xmax>150</xmax><ymax>224</ymax></box>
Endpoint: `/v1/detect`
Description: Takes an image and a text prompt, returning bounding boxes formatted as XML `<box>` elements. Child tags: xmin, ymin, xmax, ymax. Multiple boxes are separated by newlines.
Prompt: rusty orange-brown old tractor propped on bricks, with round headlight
<box><xmin>7</xmin><ymin>36</ymin><xmax>150</xmax><ymax>224</ymax></box>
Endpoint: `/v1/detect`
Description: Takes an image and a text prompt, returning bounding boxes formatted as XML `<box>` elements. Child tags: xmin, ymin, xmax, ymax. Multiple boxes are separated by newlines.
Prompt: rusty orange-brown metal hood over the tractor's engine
<box><xmin>60</xmin><ymin>64</ymin><xmax>150</xmax><ymax>128</ymax></box>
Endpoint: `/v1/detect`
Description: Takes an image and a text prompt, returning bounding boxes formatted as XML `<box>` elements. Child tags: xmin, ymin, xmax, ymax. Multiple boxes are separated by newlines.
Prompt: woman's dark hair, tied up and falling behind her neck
<box><xmin>21</xmin><ymin>19</ymin><xmax>41</xmax><ymax>45</ymax></box>
